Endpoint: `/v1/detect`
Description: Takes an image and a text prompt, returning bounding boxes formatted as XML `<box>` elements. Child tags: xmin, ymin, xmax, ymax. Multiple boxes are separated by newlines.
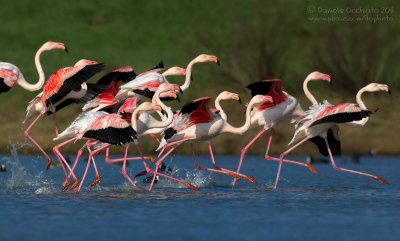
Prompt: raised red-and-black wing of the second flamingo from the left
<box><xmin>42</xmin><ymin>63</ymin><xmax>104</xmax><ymax>106</ymax></box>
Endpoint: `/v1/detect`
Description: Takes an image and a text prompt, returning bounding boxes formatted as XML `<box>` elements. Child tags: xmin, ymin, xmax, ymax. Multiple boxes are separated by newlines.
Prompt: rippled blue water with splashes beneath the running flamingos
<box><xmin>0</xmin><ymin>146</ymin><xmax>400</xmax><ymax>241</ymax></box>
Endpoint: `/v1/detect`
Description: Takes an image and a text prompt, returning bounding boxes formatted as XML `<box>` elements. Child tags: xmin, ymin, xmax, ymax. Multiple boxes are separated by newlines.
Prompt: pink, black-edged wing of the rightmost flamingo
<box><xmin>309</xmin><ymin>103</ymin><xmax>372</xmax><ymax>127</ymax></box>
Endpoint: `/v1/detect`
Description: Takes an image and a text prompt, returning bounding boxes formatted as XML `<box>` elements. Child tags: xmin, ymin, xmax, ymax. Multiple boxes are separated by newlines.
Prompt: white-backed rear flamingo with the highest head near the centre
<box><xmin>114</xmin><ymin>54</ymin><xmax>219</xmax><ymax>100</ymax></box>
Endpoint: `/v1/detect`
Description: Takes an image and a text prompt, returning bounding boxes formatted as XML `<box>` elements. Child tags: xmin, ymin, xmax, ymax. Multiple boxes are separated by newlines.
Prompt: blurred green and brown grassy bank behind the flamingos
<box><xmin>0</xmin><ymin>0</ymin><xmax>400</xmax><ymax>155</ymax></box>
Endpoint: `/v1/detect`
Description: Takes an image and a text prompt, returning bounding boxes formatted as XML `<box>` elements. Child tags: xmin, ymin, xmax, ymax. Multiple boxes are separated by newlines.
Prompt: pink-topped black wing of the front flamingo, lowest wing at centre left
<box><xmin>83</xmin><ymin>114</ymin><xmax>136</xmax><ymax>145</ymax></box>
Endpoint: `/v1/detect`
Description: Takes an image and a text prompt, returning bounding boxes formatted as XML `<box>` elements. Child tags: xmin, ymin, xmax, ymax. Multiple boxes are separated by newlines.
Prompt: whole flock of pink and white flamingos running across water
<box><xmin>0</xmin><ymin>41</ymin><xmax>390</xmax><ymax>193</ymax></box>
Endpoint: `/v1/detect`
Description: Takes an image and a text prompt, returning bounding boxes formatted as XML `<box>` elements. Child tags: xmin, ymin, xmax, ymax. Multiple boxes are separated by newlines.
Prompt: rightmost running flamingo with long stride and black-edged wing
<box><xmin>274</xmin><ymin>83</ymin><xmax>390</xmax><ymax>189</ymax></box>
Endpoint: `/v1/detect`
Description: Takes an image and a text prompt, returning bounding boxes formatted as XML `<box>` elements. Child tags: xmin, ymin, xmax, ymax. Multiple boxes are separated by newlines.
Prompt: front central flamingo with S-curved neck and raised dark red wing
<box><xmin>150</xmin><ymin>91</ymin><xmax>273</xmax><ymax>189</ymax></box>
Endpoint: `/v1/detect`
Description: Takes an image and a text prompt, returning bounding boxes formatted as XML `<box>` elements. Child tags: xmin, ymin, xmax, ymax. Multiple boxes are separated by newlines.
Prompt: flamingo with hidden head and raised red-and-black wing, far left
<box><xmin>23</xmin><ymin>59</ymin><xmax>103</xmax><ymax>170</ymax></box>
